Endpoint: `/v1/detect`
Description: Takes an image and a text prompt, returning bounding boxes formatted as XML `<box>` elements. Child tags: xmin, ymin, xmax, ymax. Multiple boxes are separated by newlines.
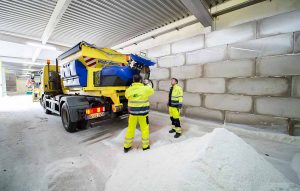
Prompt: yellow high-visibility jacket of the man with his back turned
<box><xmin>125</xmin><ymin>83</ymin><xmax>154</xmax><ymax>115</ymax></box>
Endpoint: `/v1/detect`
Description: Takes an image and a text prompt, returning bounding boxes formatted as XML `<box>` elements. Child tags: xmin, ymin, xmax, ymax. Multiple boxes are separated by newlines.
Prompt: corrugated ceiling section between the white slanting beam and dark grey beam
<box><xmin>51</xmin><ymin>0</ymin><xmax>190</xmax><ymax>47</ymax></box>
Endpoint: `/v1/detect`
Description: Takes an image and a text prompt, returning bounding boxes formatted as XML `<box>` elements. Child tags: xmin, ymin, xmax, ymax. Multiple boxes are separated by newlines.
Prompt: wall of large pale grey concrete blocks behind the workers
<box><xmin>147</xmin><ymin>10</ymin><xmax>300</xmax><ymax>134</ymax></box>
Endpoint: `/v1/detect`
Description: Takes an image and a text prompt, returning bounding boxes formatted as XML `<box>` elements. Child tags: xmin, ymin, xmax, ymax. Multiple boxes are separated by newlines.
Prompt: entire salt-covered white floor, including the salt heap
<box><xmin>0</xmin><ymin>96</ymin><xmax>300</xmax><ymax>191</ymax></box>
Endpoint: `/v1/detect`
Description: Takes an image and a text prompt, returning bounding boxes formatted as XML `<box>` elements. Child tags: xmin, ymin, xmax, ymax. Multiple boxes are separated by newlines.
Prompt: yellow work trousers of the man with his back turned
<box><xmin>124</xmin><ymin>115</ymin><xmax>150</xmax><ymax>149</ymax></box>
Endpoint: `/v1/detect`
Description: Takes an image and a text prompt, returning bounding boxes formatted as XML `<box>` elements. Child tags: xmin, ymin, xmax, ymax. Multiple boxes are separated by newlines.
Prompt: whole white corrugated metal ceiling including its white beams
<box><xmin>0</xmin><ymin>0</ymin><xmax>236</xmax><ymax>77</ymax></box>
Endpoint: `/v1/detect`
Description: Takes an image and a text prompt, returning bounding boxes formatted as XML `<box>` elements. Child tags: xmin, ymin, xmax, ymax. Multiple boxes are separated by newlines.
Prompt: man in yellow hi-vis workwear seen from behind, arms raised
<box><xmin>124</xmin><ymin>75</ymin><xmax>154</xmax><ymax>153</ymax></box>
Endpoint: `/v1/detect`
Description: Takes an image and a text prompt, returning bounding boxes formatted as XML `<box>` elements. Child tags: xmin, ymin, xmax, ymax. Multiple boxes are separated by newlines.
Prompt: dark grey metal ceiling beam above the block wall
<box><xmin>181</xmin><ymin>0</ymin><xmax>213</xmax><ymax>27</ymax></box>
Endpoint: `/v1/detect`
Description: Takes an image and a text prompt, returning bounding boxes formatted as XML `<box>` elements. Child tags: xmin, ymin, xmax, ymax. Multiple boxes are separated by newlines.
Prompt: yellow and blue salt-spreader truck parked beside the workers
<box><xmin>40</xmin><ymin>42</ymin><xmax>155</xmax><ymax>132</ymax></box>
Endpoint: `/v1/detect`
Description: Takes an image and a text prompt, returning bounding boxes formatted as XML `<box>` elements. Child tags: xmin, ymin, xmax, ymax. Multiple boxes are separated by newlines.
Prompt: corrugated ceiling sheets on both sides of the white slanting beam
<box><xmin>0</xmin><ymin>0</ymin><xmax>190</xmax><ymax>47</ymax></box>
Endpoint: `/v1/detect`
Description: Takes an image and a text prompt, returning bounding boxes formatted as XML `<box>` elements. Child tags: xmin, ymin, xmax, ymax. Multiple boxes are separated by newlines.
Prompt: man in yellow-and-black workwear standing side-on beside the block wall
<box><xmin>168</xmin><ymin>78</ymin><xmax>183</xmax><ymax>138</ymax></box>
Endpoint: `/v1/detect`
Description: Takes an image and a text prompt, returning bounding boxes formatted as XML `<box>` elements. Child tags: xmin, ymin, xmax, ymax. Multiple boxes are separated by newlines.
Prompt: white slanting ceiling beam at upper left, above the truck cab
<box><xmin>32</xmin><ymin>0</ymin><xmax>72</xmax><ymax>62</ymax></box>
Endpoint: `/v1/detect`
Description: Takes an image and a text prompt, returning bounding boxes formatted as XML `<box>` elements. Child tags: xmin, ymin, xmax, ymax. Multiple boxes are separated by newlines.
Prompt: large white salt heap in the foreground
<box><xmin>105</xmin><ymin>128</ymin><xmax>300</xmax><ymax>191</ymax></box>
